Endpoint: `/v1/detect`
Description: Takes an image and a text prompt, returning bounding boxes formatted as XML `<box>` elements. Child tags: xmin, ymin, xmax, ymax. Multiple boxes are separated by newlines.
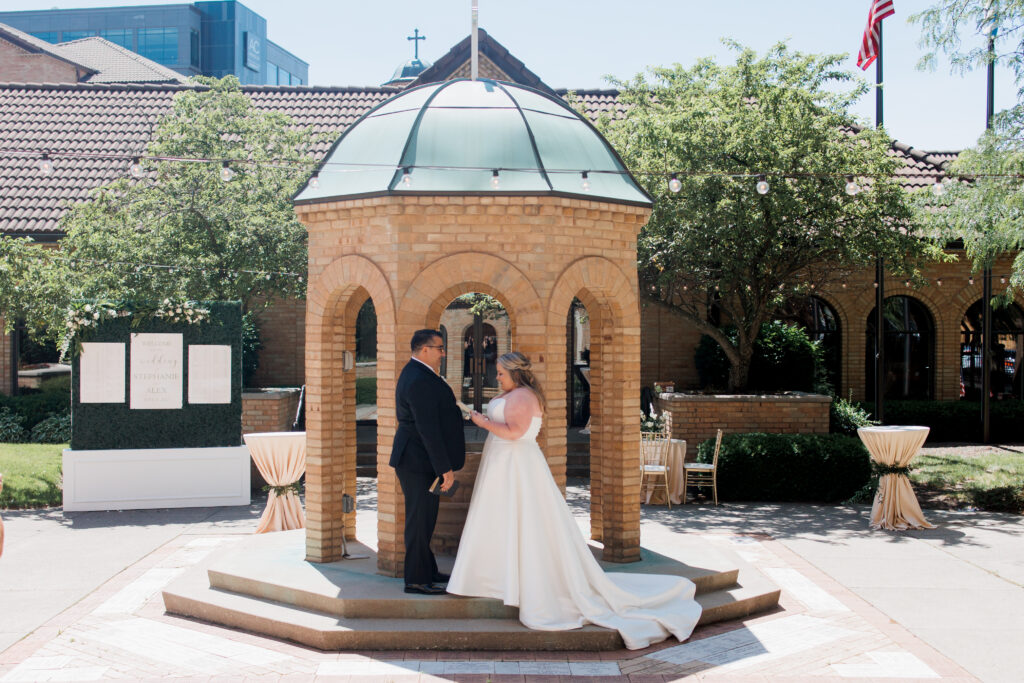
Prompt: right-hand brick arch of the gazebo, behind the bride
<box><xmin>547</xmin><ymin>256</ymin><xmax>640</xmax><ymax>561</ymax></box>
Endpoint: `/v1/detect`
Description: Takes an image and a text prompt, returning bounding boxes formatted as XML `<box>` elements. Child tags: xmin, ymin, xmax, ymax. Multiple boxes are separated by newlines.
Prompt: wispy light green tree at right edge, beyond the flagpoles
<box><xmin>910</xmin><ymin>0</ymin><xmax>1024</xmax><ymax>294</ymax></box>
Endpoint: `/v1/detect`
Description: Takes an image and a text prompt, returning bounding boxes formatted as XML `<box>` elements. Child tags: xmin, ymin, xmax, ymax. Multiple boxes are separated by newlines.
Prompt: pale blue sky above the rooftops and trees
<box><xmin>9</xmin><ymin>0</ymin><xmax>1017</xmax><ymax>152</ymax></box>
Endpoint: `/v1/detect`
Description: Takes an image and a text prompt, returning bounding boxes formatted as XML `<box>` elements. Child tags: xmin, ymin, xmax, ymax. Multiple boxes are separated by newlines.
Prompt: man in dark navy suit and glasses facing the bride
<box><xmin>389</xmin><ymin>330</ymin><xmax>466</xmax><ymax>595</ymax></box>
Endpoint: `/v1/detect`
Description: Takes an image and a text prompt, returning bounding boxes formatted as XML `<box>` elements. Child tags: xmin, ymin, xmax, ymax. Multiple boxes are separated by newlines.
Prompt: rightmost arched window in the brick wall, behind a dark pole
<box><xmin>961</xmin><ymin>300</ymin><xmax>1024</xmax><ymax>400</ymax></box>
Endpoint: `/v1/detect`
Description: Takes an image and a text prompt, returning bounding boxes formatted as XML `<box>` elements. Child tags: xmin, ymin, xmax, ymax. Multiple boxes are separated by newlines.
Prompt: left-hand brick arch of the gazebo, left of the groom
<box><xmin>306</xmin><ymin>255</ymin><xmax>395</xmax><ymax>562</ymax></box>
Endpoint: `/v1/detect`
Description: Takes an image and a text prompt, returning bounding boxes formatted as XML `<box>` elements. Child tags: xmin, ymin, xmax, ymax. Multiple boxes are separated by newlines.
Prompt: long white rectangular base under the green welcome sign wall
<box><xmin>62</xmin><ymin>445</ymin><xmax>250</xmax><ymax>512</ymax></box>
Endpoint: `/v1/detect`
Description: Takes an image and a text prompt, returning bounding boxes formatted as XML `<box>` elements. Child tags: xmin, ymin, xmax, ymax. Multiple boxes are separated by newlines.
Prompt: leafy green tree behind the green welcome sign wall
<box><xmin>0</xmin><ymin>76</ymin><xmax>317</xmax><ymax>348</ymax></box>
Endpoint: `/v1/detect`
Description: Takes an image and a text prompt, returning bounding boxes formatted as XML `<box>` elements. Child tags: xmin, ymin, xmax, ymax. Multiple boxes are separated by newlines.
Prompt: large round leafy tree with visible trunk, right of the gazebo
<box><xmin>599</xmin><ymin>42</ymin><xmax>930</xmax><ymax>389</ymax></box>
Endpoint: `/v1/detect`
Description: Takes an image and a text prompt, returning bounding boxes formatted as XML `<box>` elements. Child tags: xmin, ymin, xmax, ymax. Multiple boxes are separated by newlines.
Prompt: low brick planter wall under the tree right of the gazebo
<box><xmin>657</xmin><ymin>392</ymin><xmax>831</xmax><ymax>448</ymax></box>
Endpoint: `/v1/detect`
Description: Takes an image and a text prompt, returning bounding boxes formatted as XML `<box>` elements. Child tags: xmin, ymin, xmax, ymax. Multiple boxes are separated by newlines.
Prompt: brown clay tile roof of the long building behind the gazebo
<box><xmin>0</xmin><ymin>83</ymin><xmax>955</xmax><ymax>240</ymax></box>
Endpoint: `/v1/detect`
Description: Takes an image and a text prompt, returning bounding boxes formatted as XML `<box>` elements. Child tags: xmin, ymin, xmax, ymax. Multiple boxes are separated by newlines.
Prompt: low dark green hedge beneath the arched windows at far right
<box><xmin>861</xmin><ymin>400</ymin><xmax>1024</xmax><ymax>443</ymax></box>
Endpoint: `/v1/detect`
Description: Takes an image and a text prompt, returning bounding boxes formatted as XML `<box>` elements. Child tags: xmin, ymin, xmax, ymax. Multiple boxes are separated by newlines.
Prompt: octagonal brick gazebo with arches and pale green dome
<box><xmin>295</xmin><ymin>80</ymin><xmax>652</xmax><ymax>575</ymax></box>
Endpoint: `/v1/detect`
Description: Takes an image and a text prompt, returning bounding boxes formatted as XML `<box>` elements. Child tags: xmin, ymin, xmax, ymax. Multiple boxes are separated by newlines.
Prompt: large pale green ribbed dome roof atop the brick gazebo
<box><xmin>295</xmin><ymin>79</ymin><xmax>652</xmax><ymax>206</ymax></box>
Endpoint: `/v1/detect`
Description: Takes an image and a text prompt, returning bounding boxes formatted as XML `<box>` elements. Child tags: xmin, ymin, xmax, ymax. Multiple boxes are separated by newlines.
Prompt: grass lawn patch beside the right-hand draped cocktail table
<box><xmin>910</xmin><ymin>446</ymin><xmax>1024</xmax><ymax>512</ymax></box>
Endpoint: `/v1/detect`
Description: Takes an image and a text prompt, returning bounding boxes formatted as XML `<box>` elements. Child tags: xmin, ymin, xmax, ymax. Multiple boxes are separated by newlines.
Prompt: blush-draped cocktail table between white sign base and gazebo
<box><xmin>243</xmin><ymin>432</ymin><xmax>306</xmax><ymax>533</ymax></box>
